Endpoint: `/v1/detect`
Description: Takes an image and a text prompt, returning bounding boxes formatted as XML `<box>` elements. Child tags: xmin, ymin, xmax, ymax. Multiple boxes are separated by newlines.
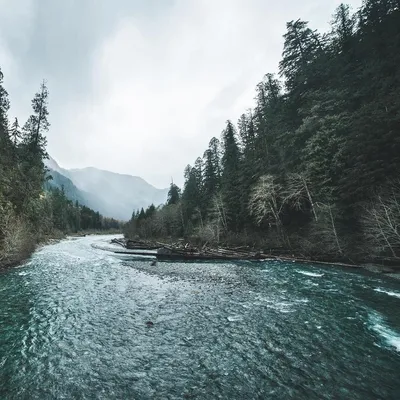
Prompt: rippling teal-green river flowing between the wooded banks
<box><xmin>0</xmin><ymin>236</ymin><xmax>400</xmax><ymax>400</ymax></box>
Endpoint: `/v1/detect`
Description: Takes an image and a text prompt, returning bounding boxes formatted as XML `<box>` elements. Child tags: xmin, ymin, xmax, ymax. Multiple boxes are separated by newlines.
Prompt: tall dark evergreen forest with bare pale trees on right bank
<box><xmin>125</xmin><ymin>0</ymin><xmax>400</xmax><ymax>261</ymax></box>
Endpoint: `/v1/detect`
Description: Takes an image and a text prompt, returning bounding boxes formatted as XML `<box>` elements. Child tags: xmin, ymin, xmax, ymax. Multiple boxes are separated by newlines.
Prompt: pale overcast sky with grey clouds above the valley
<box><xmin>0</xmin><ymin>0</ymin><xmax>361</xmax><ymax>187</ymax></box>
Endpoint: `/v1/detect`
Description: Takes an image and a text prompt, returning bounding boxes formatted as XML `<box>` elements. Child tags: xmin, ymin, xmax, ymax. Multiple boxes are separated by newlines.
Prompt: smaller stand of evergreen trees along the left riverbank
<box><xmin>0</xmin><ymin>76</ymin><xmax>120</xmax><ymax>267</ymax></box>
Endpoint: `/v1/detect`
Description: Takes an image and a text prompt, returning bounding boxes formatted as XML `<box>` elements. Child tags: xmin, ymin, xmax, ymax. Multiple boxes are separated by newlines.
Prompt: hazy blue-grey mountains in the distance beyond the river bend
<box><xmin>46</xmin><ymin>157</ymin><xmax>168</xmax><ymax>220</ymax></box>
